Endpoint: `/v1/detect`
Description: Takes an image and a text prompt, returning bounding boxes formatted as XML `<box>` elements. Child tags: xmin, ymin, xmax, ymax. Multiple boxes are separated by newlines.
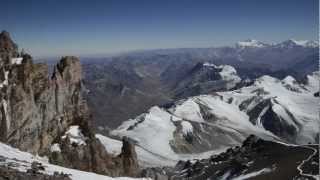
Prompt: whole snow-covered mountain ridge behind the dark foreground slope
<box><xmin>111</xmin><ymin>72</ymin><xmax>319</xmax><ymax>167</ymax></box>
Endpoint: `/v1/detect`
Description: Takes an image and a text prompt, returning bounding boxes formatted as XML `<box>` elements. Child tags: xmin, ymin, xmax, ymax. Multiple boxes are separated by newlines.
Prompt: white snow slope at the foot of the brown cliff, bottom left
<box><xmin>0</xmin><ymin>143</ymin><xmax>147</xmax><ymax>180</ymax></box>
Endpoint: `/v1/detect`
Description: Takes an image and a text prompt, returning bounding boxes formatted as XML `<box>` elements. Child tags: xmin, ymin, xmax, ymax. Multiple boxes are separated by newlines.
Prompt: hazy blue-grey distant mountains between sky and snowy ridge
<box><xmin>82</xmin><ymin>40</ymin><xmax>319</xmax><ymax>129</ymax></box>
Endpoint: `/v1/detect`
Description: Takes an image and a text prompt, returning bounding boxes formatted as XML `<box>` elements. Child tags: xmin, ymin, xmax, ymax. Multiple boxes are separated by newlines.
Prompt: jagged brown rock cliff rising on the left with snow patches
<box><xmin>0</xmin><ymin>32</ymin><xmax>138</xmax><ymax>176</ymax></box>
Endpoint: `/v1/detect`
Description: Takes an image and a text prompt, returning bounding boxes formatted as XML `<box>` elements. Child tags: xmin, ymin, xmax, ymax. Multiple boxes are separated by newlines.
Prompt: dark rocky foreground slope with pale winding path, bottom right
<box><xmin>143</xmin><ymin>135</ymin><xmax>319</xmax><ymax>180</ymax></box>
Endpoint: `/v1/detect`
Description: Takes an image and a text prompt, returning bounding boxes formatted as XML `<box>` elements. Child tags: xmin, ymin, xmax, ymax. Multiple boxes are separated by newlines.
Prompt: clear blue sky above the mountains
<box><xmin>0</xmin><ymin>0</ymin><xmax>319</xmax><ymax>57</ymax></box>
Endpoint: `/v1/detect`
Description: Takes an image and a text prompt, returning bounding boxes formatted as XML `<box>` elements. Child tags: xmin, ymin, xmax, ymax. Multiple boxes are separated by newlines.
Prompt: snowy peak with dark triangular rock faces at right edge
<box><xmin>218</xmin><ymin>72</ymin><xmax>319</xmax><ymax>144</ymax></box>
